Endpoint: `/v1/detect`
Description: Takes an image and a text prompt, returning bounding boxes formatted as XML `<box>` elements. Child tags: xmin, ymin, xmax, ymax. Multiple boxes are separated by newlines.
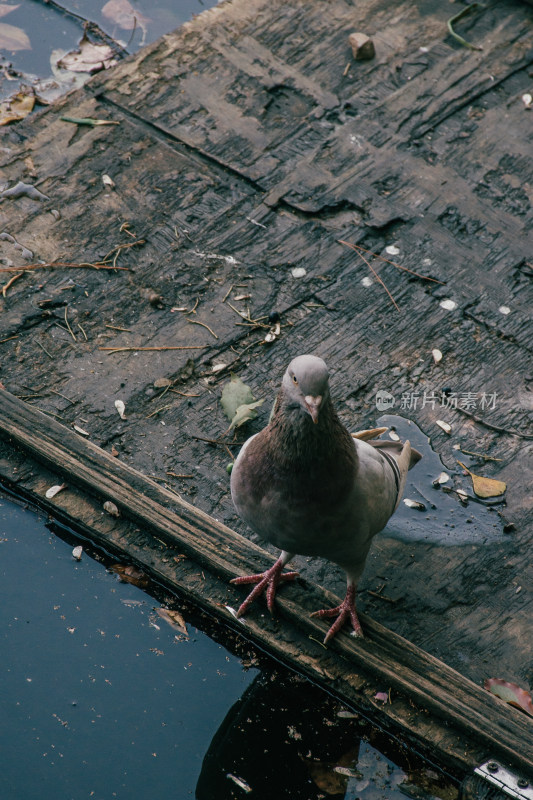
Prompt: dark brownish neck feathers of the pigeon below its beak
<box><xmin>269</xmin><ymin>391</ymin><xmax>357</xmax><ymax>472</ymax></box>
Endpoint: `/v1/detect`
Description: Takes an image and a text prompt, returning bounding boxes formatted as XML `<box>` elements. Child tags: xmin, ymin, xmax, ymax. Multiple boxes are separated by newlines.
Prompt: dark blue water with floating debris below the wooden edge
<box><xmin>0</xmin><ymin>496</ymin><xmax>457</xmax><ymax>800</ymax></box>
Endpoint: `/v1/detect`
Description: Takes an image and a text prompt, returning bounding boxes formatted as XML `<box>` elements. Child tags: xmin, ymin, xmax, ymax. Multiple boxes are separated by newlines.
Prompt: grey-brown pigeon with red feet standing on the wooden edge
<box><xmin>231</xmin><ymin>355</ymin><xmax>421</xmax><ymax>642</ymax></box>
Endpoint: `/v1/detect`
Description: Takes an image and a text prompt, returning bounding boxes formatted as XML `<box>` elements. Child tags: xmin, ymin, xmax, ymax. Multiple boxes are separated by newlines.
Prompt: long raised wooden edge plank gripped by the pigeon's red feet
<box><xmin>0</xmin><ymin>390</ymin><xmax>533</xmax><ymax>769</ymax></box>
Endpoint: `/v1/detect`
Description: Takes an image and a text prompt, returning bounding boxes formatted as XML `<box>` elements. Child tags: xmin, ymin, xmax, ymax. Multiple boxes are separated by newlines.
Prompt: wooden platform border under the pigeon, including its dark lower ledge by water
<box><xmin>0</xmin><ymin>391</ymin><xmax>533</xmax><ymax>769</ymax></box>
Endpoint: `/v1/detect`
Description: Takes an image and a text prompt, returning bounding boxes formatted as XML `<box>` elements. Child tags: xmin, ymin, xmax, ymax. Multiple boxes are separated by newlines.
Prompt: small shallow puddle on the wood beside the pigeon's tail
<box><xmin>376</xmin><ymin>414</ymin><xmax>505</xmax><ymax>545</ymax></box>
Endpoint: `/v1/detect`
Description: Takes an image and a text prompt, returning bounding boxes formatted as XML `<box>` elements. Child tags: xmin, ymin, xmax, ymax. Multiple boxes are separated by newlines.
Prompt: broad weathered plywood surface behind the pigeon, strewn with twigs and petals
<box><xmin>0</xmin><ymin>0</ymin><xmax>533</xmax><ymax>700</ymax></box>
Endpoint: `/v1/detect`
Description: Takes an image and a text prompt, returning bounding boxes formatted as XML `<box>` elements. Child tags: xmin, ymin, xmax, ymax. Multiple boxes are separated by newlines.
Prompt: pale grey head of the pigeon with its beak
<box><xmin>282</xmin><ymin>356</ymin><xmax>329</xmax><ymax>423</ymax></box>
